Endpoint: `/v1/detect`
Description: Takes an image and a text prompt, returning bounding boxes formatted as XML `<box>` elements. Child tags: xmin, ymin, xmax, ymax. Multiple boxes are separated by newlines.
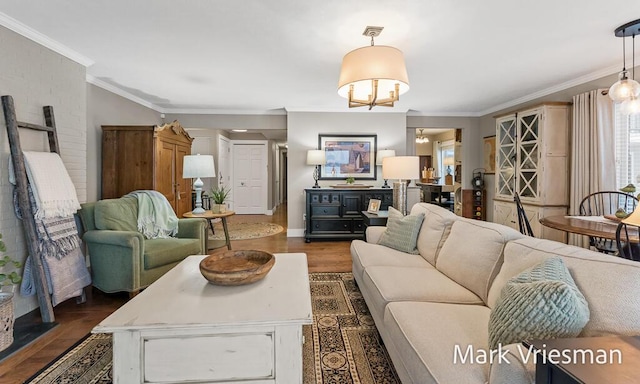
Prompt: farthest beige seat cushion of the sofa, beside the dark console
<box><xmin>351</xmin><ymin>240</ymin><xmax>433</xmax><ymax>280</ymax></box>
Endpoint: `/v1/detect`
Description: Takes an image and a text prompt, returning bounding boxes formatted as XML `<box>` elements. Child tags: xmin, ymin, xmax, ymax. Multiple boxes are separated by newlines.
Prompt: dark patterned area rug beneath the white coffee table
<box><xmin>27</xmin><ymin>273</ymin><xmax>400</xmax><ymax>384</ymax></box>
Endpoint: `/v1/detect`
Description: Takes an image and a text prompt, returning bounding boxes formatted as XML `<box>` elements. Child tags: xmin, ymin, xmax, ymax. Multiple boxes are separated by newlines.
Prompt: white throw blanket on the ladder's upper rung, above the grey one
<box><xmin>9</xmin><ymin>152</ymin><xmax>80</xmax><ymax>219</ymax></box>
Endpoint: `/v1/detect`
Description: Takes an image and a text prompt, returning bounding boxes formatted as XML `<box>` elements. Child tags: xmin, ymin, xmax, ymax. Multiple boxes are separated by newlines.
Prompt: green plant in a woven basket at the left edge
<box><xmin>0</xmin><ymin>234</ymin><xmax>22</xmax><ymax>351</ymax></box>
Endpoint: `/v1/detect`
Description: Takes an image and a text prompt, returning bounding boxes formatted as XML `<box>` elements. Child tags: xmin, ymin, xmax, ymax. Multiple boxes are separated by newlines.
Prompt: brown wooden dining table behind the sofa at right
<box><xmin>540</xmin><ymin>215</ymin><xmax>640</xmax><ymax>243</ymax></box>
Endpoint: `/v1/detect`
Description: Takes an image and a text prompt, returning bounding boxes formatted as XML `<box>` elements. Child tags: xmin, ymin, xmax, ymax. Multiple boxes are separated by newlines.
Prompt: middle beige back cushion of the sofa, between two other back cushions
<box><xmin>436</xmin><ymin>218</ymin><xmax>524</xmax><ymax>302</ymax></box>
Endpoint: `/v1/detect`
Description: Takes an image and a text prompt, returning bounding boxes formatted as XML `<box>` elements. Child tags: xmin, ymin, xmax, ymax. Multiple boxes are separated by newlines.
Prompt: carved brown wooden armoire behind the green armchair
<box><xmin>102</xmin><ymin>121</ymin><xmax>193</xmax><ymax>217</ymax></box>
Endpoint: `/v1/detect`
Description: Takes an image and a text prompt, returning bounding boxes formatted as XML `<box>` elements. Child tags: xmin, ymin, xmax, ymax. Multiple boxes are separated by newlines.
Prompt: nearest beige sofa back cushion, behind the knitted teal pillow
<box><xmin>488</xmin><ymin>237</ymin><xmax>640</xmax><ymax>337</ymax></box>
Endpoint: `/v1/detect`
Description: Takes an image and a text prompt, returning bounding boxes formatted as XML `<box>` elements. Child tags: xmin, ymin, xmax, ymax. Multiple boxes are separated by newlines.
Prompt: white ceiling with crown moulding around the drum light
<box><xmin>0</xmin><ymin>0</ymin><xmax>640</xmax><ymax>116</ymax></box>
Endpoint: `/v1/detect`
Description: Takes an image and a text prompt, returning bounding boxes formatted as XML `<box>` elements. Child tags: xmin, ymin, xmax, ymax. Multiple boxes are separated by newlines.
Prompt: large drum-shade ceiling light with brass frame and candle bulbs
<box><xmin>338</xmin><ymin>26</ymin><xmax>409</xmax><ymax>110</ymax></box>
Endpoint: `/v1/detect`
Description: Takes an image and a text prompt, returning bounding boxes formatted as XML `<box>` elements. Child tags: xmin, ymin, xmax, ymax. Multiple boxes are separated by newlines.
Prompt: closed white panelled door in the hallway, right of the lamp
<box><xmin>232</xmin><ymin>143</ymin><xmax>267</xmax><ymax>215</ymax></box>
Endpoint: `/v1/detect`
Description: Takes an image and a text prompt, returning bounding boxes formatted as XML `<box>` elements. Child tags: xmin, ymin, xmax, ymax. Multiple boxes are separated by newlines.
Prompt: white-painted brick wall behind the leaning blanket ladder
<box><xmin>0</xmin><ymin>26</ymin><xmax>87</xmax><ymax>317</ymax></box>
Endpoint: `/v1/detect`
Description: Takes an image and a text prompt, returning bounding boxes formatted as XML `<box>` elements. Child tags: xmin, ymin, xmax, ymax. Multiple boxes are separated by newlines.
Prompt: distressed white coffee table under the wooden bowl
<box><xmin>92</xmin><ymin>253</ymin><xmax>312</xmax><ymax>384</ymax></box>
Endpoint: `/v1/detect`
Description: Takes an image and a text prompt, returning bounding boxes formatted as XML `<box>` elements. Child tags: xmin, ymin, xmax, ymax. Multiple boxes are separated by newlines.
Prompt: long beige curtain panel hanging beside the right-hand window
<box><xmin>569</xmin><ymin>89</ymin><xmax>616</xmax><ymax>248</ymax></box>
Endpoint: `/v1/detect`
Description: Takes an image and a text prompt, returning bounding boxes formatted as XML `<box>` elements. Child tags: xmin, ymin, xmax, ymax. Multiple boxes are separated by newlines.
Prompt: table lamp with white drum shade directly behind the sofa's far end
<box><xmin>382</xmin><ymin>156</ymin><xmax>420</xmax><ymax>215</ymax></box>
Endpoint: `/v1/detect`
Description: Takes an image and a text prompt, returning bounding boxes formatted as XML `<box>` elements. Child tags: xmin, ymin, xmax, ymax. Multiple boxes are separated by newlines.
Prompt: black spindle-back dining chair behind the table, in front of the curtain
<box><xmin>580</xmin><ymin>191</ymin><xmax>638</xmax><ymax>254</ymax></box>
